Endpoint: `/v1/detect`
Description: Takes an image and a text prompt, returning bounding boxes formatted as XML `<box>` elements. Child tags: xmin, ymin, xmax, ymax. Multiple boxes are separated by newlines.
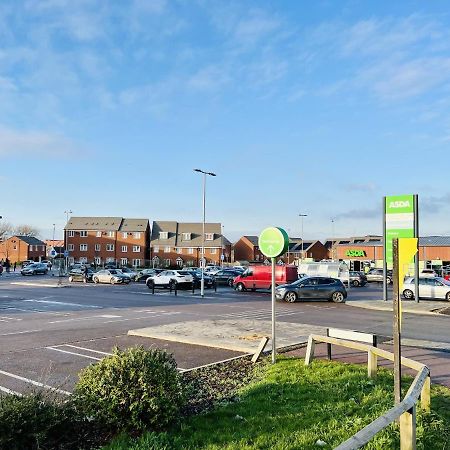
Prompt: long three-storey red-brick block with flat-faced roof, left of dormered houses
<box><xmin>64</xmin><ymin>217</ymin><xmax>150</xmax><ymax>267</ymax></box>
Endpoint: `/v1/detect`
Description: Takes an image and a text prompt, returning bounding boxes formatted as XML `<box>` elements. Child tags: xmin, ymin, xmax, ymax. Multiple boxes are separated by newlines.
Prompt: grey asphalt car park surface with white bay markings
<box><xmin>0</xmin><ymin>270</ymin><xmax>450</xmax><ymax>395</ymax></box>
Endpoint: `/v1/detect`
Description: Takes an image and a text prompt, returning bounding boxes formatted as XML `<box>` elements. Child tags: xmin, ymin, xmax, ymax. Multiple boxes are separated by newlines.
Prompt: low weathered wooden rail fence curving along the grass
<box><xmin>305</xmin><ymin>334</ymin><xmax>431</xmax><ymax>450</ymax></box>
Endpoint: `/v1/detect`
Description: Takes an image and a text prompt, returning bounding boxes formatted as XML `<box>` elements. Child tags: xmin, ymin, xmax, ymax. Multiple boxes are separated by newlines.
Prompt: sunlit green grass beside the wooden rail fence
<box><xmin>105</xmin><ymin>358</ymin><xmax>450</xmax><ymax>450</ymax></box>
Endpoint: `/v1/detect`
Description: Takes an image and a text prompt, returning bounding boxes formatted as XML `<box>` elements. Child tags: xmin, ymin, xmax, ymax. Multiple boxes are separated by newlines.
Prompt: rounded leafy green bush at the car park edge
<box><xmin>74</xmin><ymin>347</ymin><xmax>185</xmax><ymax>432</ymax></box>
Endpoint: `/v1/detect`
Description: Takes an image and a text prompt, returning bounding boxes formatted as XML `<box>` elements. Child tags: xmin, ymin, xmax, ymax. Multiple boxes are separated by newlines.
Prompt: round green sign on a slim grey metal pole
<box><xmin>258</xmin><ymin>227</ymin><xmax>289</xmax><ymax>364</ymax></box>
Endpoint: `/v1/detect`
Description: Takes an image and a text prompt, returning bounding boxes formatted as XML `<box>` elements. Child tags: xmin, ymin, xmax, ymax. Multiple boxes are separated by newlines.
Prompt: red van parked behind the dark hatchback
<box><xmin>233</xmin><ymin>265</ymin><xmax>298</xmax><ymax>292</ymax></box>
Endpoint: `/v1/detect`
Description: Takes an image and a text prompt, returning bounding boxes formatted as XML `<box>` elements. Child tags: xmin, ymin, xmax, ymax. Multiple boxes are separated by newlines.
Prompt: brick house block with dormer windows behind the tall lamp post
<box><xmin>150</xmin><ymin>221</ymin><xmax>231</xmax><ymax>267</ymax></box>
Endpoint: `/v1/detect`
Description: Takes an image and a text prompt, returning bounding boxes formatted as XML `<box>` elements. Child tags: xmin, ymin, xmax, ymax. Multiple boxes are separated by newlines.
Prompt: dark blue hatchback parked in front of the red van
<box><xmin>275</xmin><ymin>277</ymin><xmax>347</xmax><ymax>303</ymax></box>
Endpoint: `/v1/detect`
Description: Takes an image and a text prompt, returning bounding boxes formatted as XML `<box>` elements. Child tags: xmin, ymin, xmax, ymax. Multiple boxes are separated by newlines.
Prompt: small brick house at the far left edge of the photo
<box><xmin>0</xmin><ymin>236</ymin><xmax>46</xmax><ymax>264</ymax></box>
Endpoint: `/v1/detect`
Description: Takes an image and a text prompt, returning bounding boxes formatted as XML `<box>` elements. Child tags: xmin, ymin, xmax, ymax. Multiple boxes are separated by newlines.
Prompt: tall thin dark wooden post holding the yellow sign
<box><xmin>392</xmin><ymin>239</ymin><xmax>402</xmax><ymax>405</ymax></box>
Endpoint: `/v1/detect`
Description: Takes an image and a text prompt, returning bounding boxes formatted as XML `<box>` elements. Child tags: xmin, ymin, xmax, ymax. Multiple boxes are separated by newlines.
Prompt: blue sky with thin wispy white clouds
<box><xmin>0</xmin><ymin>0</ymin><xmax>450</xmax><ymax>240</ymax></box>
